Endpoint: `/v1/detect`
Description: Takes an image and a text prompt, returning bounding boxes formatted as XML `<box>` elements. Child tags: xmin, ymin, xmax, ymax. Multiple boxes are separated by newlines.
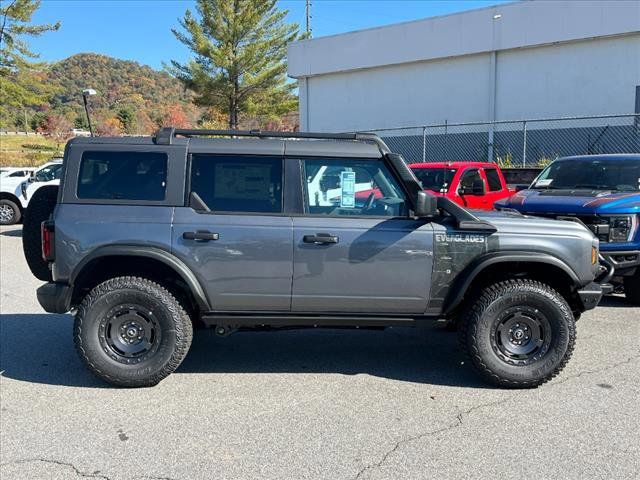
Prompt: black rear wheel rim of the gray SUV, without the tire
<box><xmin>100</xmin><ymin>304</ymin><xmax>161</xmax><ymax>364</ymax></box>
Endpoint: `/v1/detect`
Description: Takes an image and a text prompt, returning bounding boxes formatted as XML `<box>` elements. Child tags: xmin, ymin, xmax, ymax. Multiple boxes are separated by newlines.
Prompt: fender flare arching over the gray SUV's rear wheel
<box><xmin>69</xmin><ymin>245</ymin><xmax>211</xmax><ymax>312</ymax></box>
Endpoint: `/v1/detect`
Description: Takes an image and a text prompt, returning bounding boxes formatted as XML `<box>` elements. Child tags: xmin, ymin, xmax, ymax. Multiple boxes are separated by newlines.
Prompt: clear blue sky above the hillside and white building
<box><xmin>30</xmin><ymin>0</ymin><xmax>504</xmax><ymax>68</ymax></box>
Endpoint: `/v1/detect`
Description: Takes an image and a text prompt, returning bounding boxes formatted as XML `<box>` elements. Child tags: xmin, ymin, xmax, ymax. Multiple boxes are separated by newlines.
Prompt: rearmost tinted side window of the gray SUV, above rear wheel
<box><xmin>78</xmin><ymin>152</ymin><xmax>167</xmax><ymax>201</ymax></box>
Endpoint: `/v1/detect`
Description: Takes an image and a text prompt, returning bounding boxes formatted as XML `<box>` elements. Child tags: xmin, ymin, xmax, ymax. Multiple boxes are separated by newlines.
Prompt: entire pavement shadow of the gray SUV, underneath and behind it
<box><xmin>0</xmin><ymin>313</ymin><xmax>491</xmax><ymax>388</ymax></box>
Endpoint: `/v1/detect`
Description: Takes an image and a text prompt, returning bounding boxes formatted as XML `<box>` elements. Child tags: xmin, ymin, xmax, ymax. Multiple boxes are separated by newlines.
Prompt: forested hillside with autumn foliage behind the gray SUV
<box><xmin>2</xmin><ymin>53</ymin><xmax>297</xmax><ymax>137</ymax></box>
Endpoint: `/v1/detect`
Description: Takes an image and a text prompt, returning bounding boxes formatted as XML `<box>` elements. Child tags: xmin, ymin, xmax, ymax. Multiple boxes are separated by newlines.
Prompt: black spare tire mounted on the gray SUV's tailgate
<box><xmin>22</xmin><ymin>185</ymin><xmax>58</xmax><ymax>282</ymax></box>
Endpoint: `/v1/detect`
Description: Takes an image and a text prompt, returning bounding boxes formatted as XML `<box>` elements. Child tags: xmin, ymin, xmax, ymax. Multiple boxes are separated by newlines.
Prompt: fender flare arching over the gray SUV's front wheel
<box><xmin>443</xmin><ymin>252</ymin><xmax>580</xmax><ymax>316</ymax></box>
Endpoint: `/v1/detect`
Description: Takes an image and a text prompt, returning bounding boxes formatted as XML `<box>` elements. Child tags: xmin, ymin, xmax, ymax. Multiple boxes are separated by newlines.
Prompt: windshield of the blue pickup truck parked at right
<box><xmin>532</xmin><ymin>159</ymin><xmax>640</xmax><ymax>192</ymax></box>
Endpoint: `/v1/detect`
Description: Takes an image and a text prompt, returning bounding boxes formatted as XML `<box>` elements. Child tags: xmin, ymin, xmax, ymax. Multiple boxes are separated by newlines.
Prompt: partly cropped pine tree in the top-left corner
<box><xmin>0</xmin><ymin>0</ymin><xmax>60</xmax><ymax>123</ymax></box>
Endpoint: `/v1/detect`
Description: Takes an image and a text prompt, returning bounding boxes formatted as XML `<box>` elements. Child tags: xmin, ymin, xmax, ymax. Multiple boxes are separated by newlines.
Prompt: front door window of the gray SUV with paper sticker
<box><xmin>304</xmin><ymin>159</ymin><xmax>407</xmax><ymax>217</ymax></box>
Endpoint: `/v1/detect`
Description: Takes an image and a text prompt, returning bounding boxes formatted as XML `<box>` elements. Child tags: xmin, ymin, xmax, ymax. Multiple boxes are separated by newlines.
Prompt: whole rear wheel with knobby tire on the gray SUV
<box><xmin>73</xmin><ymin>277</ymin><xmax>193</xmax><ymax>387</ymax></box>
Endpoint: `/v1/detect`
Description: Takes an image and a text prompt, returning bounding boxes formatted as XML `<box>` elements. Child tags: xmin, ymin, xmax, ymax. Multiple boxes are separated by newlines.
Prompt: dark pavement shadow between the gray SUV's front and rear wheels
<box><xmin>178</xmin><ymin>325</ymin><xmax>491</xmax><ymax>388</ymax></box>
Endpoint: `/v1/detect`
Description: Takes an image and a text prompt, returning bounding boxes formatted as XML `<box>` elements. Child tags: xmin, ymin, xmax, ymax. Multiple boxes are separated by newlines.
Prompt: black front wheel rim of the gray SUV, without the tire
<box><xmin>492</xmin><ymin>306</ymin><xmax>551</xmax><ymax>365</ymax></box>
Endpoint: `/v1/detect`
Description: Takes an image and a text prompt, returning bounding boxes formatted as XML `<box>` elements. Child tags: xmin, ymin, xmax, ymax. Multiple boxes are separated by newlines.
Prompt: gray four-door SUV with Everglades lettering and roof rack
<box><xmin>24</xmin><ymin>128</ymin><xmax>602</xmax><ymax>388</ymax></box>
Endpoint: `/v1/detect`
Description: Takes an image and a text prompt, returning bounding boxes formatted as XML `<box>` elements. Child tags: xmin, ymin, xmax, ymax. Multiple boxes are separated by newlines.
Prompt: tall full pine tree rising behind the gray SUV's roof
<box><xmin>169</xmin><ymin>0</ymin><xmax>298</xmax><ymax>129</ymax></box>
